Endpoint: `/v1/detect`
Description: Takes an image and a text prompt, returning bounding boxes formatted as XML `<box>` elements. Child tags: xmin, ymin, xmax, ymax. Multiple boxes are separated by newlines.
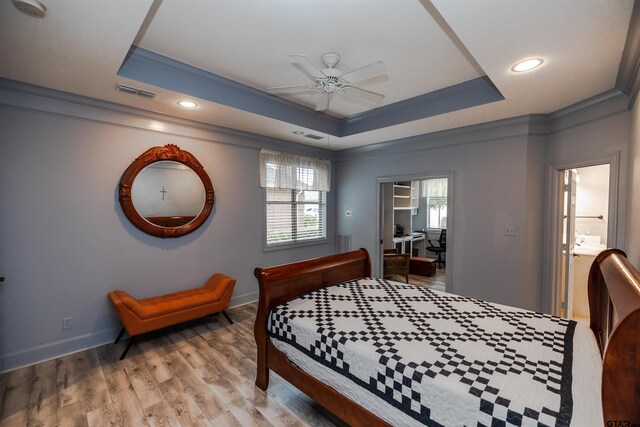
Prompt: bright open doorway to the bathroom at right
<box><xmin>556</xmin><ymin>163</ymin><xmax>614</xmax><ymax>325</ymax></box>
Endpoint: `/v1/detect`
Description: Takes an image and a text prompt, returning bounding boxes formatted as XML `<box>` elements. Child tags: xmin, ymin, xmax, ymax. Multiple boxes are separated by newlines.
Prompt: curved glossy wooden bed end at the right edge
<box><xmin>589</xmin><ymin>249</ymin><xmax>640</xmax><ymax>426</ymax></box>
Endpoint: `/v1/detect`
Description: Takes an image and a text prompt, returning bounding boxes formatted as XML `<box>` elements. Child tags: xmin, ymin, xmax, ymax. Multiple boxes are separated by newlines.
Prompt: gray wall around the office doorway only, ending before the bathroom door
<box><xmin>337</xmin><ymin>118</ymin><xmax>544</xmax><ymax>308</ymax></box>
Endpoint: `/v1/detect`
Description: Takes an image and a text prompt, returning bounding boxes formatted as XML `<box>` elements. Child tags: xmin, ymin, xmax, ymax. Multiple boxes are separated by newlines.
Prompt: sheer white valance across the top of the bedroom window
<box><xmin>260</xmin><ymin>150</ymin><xmax>331</xmax><ymax>191</ymax></box>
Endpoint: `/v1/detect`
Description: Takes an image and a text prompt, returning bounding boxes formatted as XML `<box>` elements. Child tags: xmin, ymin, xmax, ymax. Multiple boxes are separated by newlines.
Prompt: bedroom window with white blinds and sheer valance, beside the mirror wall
<box><xmin>260</xmin><ymin>150</ymin><xmax>331</xmax><ymax>247</ymax></box>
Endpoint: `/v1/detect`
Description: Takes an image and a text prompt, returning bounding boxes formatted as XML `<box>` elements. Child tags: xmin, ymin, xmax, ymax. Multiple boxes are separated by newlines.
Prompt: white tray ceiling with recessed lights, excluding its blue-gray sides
<box><xmin>0</xmin><ymin>0</ymin><xmax>633</xmax><ymax>150</ymax></box>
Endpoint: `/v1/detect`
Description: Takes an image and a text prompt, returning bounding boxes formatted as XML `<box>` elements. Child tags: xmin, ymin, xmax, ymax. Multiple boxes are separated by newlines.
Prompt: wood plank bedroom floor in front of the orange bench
<box><xmin>0</xmin><ymin>303</ymin><xmax>344</xmax><ymax>426</ymax></box>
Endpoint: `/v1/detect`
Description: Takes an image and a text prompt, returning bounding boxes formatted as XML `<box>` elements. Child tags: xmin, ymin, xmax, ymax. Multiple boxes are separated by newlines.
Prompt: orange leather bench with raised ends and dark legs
<box><xmin>109</xmin><ymin>273</ymin><xmax>236</xmax><ymax>360</ymax></box>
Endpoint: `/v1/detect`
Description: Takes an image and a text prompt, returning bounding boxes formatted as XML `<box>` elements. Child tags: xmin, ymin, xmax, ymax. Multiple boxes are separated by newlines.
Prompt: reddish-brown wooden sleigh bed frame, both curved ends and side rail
<box><xmin>254</xmin><ymin>249</ymin><xmax>640</xmax><ymax>427</ymax></box>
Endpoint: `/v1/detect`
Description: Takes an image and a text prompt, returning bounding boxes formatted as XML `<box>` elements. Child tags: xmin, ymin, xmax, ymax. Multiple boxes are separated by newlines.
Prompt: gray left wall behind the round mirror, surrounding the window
<box><xmin>0</xmin><ymin>85</ymin><xmax>335</xmax><ymax>370</ymax></box>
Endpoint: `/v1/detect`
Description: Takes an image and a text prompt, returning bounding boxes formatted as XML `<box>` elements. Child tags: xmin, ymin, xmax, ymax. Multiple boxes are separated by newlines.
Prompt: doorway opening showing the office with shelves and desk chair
<box><xmin>378</xmin><ymin>174</ymin><xmax>453</xmax><ymax>291</ymax></box>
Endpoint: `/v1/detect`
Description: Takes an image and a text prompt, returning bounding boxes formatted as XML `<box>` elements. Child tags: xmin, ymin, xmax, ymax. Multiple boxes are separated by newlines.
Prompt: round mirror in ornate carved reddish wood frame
<box><xmin>119</xmin><ymin>144</ymin><xmax>214</xmax><ymax>237</ymax></box>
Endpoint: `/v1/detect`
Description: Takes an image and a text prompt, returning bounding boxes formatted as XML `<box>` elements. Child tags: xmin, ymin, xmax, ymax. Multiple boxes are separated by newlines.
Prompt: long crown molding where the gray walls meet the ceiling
<box><xmin>0</xmin><ymin>78</ymin><xmax>629</xmax><ymax>161</ymax></box>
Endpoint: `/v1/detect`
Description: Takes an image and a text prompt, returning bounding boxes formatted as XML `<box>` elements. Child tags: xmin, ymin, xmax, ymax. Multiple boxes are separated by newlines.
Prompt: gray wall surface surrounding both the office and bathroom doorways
<box><xmin>337</xmin><ymin>96</ymin><xmax>629</xmax><ymax>312</ymax></box>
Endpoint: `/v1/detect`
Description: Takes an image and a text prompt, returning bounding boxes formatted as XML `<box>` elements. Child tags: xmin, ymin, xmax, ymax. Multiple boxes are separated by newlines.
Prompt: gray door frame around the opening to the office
<box><xmin>374</xmin><ymin>171</ymin><xmax>455</xmax><ymax>292</ymax></box>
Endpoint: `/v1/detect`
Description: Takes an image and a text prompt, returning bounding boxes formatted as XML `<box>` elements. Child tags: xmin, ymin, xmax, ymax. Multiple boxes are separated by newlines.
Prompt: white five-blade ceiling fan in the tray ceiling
<box><xmin>267</xmin><ymin>52</ymin><xmax>388</xmax><ymax>111</ymax></box>
